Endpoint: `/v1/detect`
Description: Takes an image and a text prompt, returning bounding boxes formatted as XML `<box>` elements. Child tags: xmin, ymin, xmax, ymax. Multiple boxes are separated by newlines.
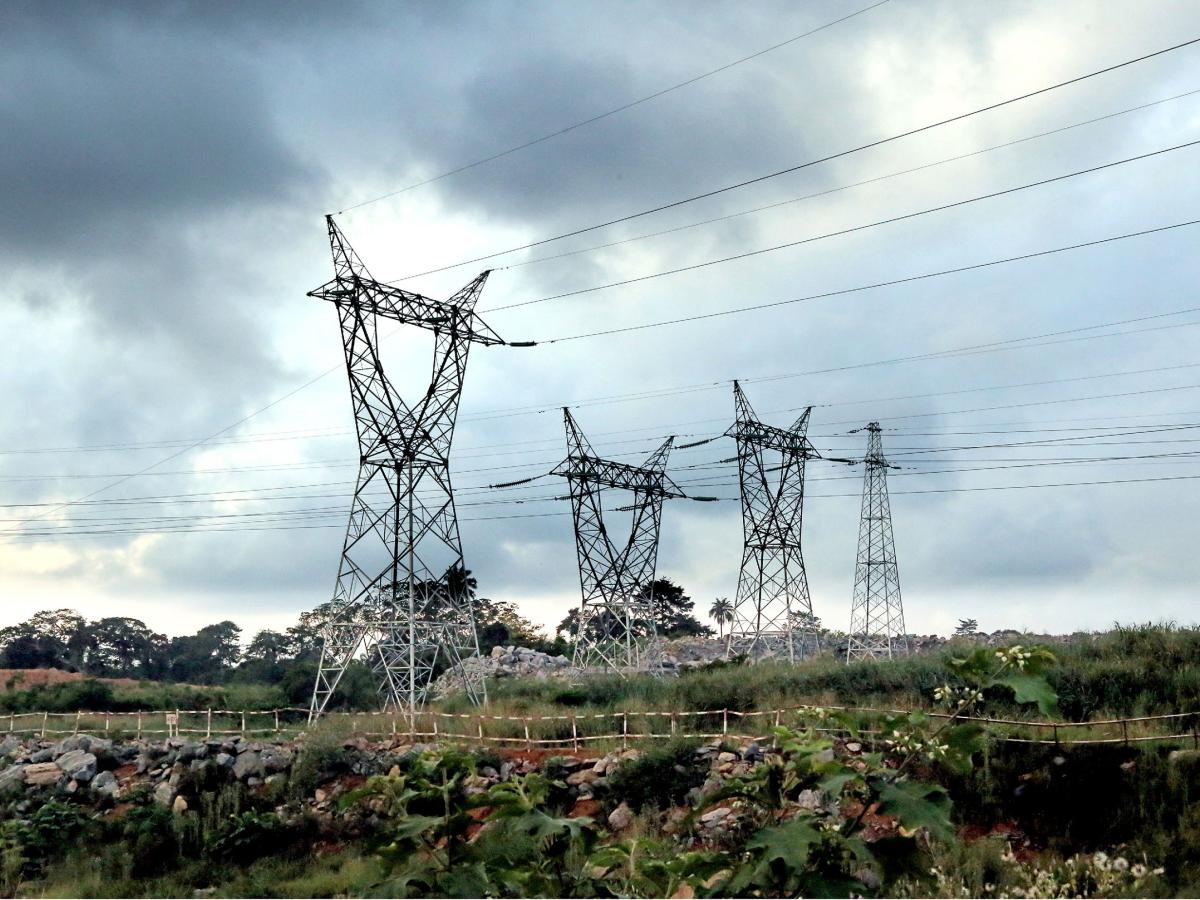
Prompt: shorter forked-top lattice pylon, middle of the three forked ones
<box><xmin>551</xmin><ymin>408</ymin><xmax>683</xmax><ymax>672</ymax></box>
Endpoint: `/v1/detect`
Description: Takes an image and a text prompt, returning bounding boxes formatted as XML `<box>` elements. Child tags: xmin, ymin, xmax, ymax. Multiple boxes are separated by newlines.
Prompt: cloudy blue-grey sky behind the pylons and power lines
<box><xmin>0</xmin><ymin>0</ymin><xmax>1200</xmax><ymax>648</ymax></box>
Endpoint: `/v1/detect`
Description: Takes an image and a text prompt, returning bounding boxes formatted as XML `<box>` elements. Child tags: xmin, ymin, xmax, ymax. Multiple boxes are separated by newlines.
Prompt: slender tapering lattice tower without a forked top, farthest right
<box><xmin>846</xmin><ymin>422</ymin><xmax>908</xmax><ymax>662</ymax></box>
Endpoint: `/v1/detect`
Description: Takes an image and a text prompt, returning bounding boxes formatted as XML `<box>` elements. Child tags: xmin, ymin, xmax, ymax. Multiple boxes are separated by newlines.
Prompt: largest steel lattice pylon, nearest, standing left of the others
<box><xmin>308</xmin><ymin>216</ymin><xmax>504</xmax><ymax>719</ymax></box>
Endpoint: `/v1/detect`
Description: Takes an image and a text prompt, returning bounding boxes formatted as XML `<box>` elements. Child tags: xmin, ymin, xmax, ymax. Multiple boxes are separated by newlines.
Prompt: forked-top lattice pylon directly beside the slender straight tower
<box><xmin>725</xmin><ymin>382</ymin><xmax>820</xmax><ymax>662</ymax></box>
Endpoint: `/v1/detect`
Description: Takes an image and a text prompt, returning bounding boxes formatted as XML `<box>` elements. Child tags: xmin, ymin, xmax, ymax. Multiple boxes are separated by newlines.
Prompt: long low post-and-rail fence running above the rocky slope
<box><xmin>0</xmin><ymin>706</ymin><xmax>1200</xmax><ymax>750</ymax></box>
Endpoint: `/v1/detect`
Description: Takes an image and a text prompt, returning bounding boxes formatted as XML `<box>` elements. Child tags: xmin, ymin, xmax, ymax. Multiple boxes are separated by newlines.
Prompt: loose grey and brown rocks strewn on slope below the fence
<box><xmin>0</xmin><ymin>734</ymin><xmax>907</xmax><ymax>839</ymax></box>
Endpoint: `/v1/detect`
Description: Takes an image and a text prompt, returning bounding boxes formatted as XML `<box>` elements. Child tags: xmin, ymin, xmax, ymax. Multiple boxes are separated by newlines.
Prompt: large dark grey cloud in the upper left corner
<box><xmin>0</xmin><ymin>15</ymin><xmax>314</xmax><ymax>260</ymax></box>
